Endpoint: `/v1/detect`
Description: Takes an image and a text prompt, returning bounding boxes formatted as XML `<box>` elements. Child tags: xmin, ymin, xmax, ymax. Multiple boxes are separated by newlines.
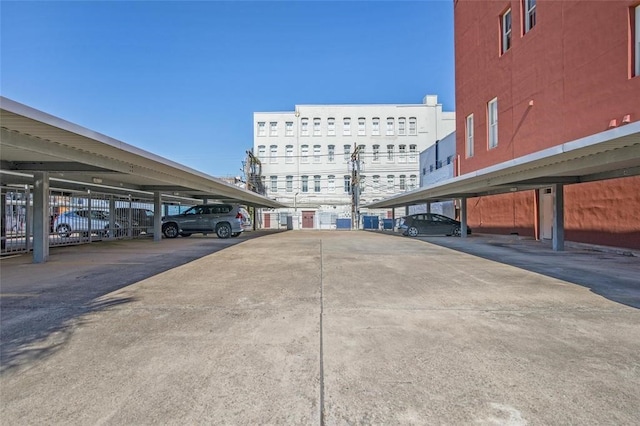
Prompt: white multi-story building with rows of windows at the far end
<box><xmin>253</xmin><ymin>95</ymin><xmax>455</xmax><ymax>229</ymax></box>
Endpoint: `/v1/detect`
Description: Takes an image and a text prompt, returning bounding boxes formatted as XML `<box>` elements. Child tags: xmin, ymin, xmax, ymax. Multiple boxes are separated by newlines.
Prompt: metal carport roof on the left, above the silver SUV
<box><xmin>0</xmin><ymin>97</ymin><xmax>284</xmax><ymax>208</ymax></box>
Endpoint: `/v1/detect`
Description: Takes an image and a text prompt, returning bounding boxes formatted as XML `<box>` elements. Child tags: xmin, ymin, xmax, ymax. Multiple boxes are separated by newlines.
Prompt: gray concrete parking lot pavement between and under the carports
<box><xmin>0</xmin><ymin>231</ymin><xmax>640</xmax><ymax>425</ymax></box>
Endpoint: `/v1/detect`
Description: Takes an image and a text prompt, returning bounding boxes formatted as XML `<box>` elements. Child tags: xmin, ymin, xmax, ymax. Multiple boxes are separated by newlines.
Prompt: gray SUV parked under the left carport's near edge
<box><xmin>162</xmin><ymin>204</ymin><xmax>244</xmax><ymax>238</ymax></box>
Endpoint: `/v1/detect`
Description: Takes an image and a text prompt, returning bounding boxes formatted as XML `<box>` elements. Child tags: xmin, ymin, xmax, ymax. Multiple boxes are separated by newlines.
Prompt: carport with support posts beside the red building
<box><xmin>364</xmin><ymin>122</ymin><xmax>640</xmax><ymax>251</ymax></box>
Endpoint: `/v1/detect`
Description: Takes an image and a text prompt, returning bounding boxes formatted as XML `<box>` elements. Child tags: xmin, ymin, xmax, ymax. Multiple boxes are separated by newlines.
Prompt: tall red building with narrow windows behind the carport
<box><xmin>454</xmin><ymin>0</ymin><xmax>640</xmax><ymax>249</ymax></box>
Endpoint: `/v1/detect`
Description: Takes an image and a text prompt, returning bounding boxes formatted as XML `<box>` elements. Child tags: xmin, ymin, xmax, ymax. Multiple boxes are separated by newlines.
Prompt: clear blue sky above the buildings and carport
<box><xmin>0</xmin><ymin>0</ymin><xmax>455</xmax><ymax>176</ymax></box>
